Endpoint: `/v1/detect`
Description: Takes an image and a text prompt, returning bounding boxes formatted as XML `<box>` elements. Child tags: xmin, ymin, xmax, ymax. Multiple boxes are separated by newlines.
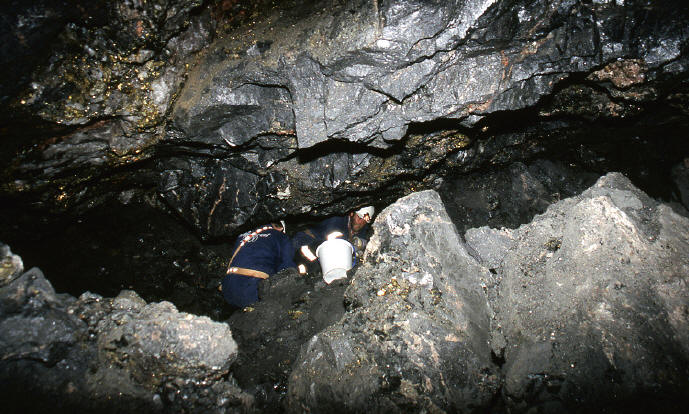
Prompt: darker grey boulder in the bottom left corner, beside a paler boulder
<box><xmin>0</xmin><ymin>268</ymin><xmax>107</xmax><ymax>412</ymax></box>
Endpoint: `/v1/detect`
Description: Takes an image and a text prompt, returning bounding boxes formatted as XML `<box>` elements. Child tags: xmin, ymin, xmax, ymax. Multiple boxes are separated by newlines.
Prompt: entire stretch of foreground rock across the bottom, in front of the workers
<box><xmin>0</xmin><ymin>170</ymin><xmax>689</xmax><ymax>412</ymax></box>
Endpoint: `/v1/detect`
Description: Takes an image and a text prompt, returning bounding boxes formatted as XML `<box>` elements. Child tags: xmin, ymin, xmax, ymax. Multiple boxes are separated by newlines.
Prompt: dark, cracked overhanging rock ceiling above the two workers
<box><xmin>0</xmin><ymin>0</ymin><xmax>689</xmax><ymax>239</ymax></box>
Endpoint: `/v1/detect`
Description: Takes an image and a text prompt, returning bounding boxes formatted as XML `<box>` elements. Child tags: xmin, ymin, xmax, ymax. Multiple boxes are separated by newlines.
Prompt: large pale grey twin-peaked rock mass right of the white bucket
<box><xmin>289</xmin><ymin>173</ymin><xmax>689</xmax><ymax>412</ymax></box>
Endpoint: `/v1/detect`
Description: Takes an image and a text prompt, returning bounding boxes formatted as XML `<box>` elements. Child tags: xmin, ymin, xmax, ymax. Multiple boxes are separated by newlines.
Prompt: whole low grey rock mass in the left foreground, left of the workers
<box><xmin>0</xmin><ymin>249</ymin><xmax>247</xmax><ymax>413</ymax></box>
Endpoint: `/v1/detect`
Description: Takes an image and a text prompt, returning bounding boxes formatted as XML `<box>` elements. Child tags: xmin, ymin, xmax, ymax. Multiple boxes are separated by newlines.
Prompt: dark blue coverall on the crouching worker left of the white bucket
<box><xmin>222</xmin><ymin>228</ymin><xmax>296</xmax><ymax>308</ymax></box>
